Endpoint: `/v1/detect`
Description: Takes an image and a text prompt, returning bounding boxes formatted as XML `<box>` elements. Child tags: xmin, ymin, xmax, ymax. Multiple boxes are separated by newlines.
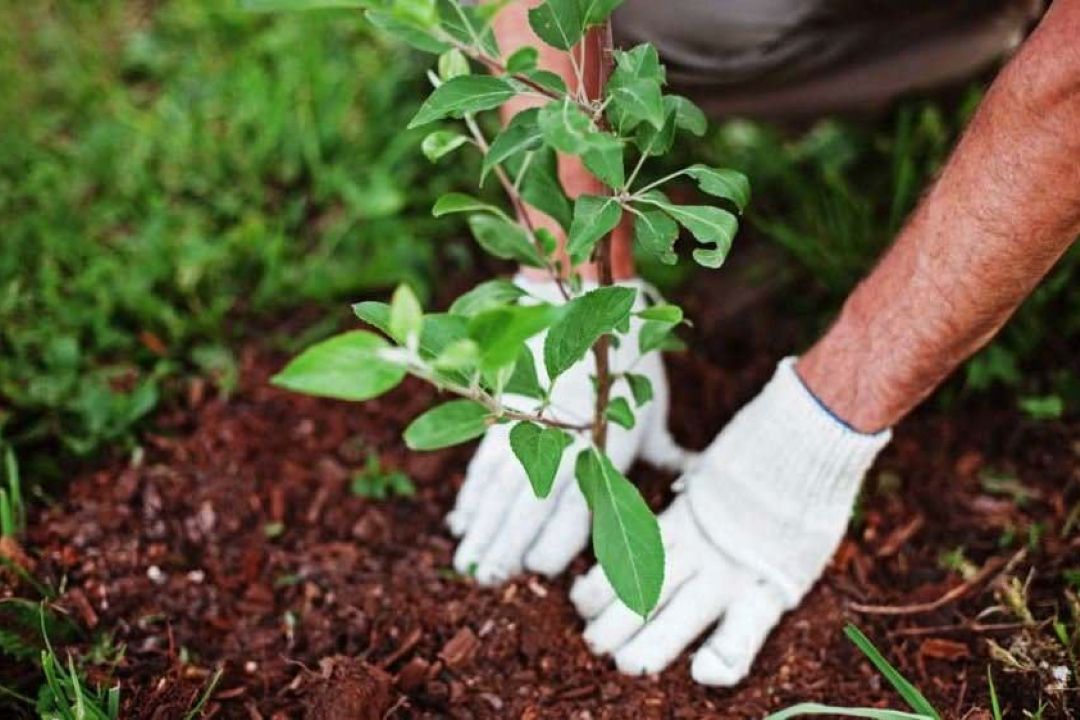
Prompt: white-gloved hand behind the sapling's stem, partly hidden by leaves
<box><xmin>446</xmin><ymin>276</ymin><xmax>689</xmax><ymax>585</ymax></box>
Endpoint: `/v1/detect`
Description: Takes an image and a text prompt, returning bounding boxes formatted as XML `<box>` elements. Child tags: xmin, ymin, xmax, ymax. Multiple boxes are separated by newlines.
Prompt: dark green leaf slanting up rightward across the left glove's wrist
<box><xmin>543</xmin><ymin>286</ymin><xmax>637</xmax><ymax>380</ymax></box>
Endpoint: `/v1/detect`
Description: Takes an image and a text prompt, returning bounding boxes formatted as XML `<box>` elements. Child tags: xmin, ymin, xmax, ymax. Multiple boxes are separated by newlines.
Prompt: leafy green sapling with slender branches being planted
<box><xmin>258</xmin><ymin>0</ymin><xmax>750</xmax><ymax>615</ymax></box>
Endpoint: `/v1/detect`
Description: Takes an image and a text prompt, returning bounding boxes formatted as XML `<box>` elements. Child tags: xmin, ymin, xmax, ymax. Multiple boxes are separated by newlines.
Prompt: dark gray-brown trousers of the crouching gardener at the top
<box><xmin>612</xmin><ymin>0</ymin><xmax>1043</xmax><ymax>117</ymax></box>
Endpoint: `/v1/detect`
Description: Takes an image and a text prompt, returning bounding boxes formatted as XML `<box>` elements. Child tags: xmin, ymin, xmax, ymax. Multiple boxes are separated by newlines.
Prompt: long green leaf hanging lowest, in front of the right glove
<box><xmin>575</xmin><ymin>448</ymin><xmax>664</xmax><ymax>617</ymax></box>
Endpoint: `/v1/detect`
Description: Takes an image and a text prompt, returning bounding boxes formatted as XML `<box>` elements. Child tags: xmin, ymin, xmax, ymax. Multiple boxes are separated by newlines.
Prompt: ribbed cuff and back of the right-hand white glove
<box><xmin>687</xmin><ymin>357</ymin><xmax>892</xmax><ymax>607</ymax></box>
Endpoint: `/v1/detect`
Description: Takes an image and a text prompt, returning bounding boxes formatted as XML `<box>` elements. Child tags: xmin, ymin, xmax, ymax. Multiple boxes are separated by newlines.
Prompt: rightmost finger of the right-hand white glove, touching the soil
<box><xmin>690</xmin><ymin>581</ymin><xmax>784</xmax><ymax>687</ymax></box>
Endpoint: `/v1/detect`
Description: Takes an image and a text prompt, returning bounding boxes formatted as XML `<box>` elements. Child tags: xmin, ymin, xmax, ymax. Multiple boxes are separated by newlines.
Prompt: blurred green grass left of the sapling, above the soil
<box><xmin>0</xmin><ymin>0</ymin><xmax>475</xmax><ymax>472</ymax></box>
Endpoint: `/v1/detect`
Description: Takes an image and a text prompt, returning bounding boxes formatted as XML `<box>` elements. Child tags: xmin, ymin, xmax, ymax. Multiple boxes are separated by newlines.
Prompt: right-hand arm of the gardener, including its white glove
<box><xmin>571</xmin><ymin>0</ymin><xmax>1080</xmax><ymax>685</ymax></box>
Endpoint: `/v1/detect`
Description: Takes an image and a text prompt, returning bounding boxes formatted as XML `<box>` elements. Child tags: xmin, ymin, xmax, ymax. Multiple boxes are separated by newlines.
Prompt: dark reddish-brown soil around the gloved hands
<box><xmin>2</xmin><ymin>274</ymin><xmax>1080</xmax><ymax>719</ymax></box>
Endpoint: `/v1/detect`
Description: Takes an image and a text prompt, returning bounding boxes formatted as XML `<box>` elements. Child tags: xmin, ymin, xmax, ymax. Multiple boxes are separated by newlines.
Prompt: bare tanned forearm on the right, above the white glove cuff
<box><xmin>797</xmin><ymin>0</ymin><xmax>1080</xmax><ymax>432</ymax></box>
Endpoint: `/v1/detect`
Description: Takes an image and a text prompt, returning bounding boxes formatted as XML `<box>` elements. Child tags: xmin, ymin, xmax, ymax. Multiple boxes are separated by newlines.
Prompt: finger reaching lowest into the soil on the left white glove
<box><xmin>476</xmin><ymin>463</ymin><xmax>572</xmax><ymax>585</ymax></box>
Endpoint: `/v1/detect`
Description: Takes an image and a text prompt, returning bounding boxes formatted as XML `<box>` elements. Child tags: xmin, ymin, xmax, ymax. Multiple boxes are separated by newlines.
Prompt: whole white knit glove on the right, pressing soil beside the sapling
<box><xmin>570</xmin><ymin>357</ymin><xmax>890</xmax><ymax>685</ymax></box>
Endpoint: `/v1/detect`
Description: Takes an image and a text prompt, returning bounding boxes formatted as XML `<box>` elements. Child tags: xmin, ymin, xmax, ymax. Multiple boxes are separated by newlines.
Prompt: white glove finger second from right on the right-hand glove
<box><xmin>615</xmin><ymin>571</ymin><xmax>731</xmax><ymax>675</ymax></box>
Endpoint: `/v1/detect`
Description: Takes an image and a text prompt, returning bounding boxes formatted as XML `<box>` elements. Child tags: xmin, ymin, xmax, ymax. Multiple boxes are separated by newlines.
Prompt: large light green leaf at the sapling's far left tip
<box><xmin>270</xmin><ymin>330</ymin><xmax>405</xmax><ymax>400</ymax></box>
